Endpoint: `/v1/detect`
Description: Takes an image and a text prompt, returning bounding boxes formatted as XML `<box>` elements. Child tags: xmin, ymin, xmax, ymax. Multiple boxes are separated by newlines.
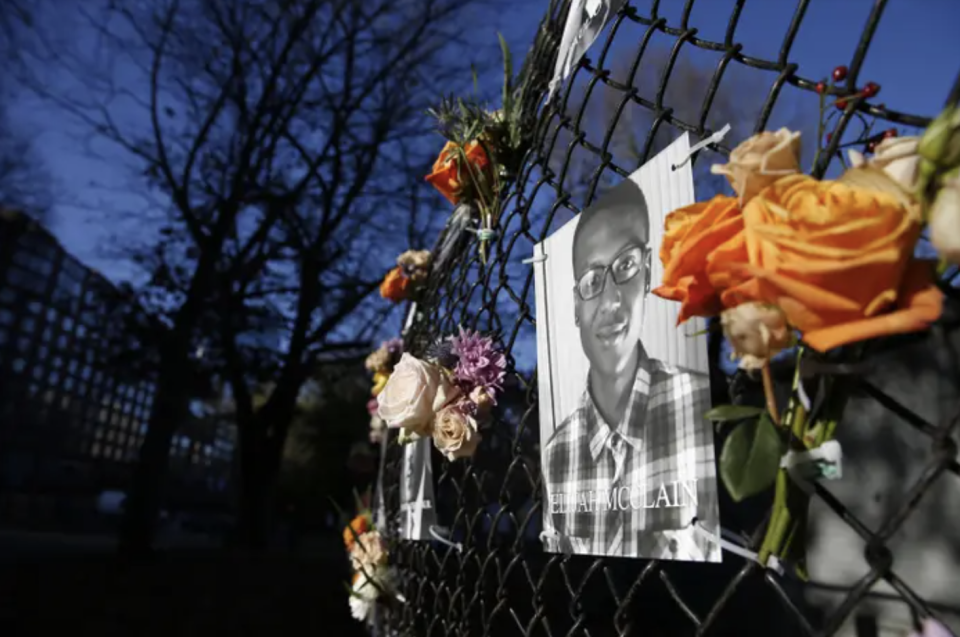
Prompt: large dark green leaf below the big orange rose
<box><xmin>720</xmin><ymin>413</ymin><xmax>784</xmax><ymax>502</ymax></box>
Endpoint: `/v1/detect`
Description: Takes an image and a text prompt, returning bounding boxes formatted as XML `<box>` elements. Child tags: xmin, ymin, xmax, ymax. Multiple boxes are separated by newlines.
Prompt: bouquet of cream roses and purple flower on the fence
<box><xmin>377</xmin><ymin>328</ymin><xmax>507</xmax><ymax>461</ymax></box>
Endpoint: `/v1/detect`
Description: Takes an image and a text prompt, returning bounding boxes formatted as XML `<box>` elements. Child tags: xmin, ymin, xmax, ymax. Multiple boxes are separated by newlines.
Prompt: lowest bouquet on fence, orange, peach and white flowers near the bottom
<box><xmin>343</xmin><ymin>494</ymin><xmax>405</xmax><ymax>622</ymax></box>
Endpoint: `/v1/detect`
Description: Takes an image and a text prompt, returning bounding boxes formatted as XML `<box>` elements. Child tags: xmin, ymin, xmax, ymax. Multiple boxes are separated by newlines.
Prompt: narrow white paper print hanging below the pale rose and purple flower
<box><xmin>400</xmin><ymin>438</ymin><xmax>437</xmax><ymax>540</ymax></box>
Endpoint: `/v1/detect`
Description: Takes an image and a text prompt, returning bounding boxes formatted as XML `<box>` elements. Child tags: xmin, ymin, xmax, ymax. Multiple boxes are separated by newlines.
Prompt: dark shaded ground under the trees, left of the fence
<box><xmin>0</xmin><ymin>533</ymin><xmax>366</xmax><ymax>637</ymax></box>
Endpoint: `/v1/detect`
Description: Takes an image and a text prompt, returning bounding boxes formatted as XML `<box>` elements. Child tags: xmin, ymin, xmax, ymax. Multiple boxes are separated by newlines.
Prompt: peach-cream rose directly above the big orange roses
<box><xmin>710</xmin><ymin>128</ymin><xmax>800</xmax><ymax>206</ymax></box>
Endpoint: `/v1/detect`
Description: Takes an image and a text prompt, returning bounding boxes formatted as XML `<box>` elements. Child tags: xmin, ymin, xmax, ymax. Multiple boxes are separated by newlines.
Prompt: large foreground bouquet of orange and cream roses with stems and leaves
<box><xmin>653</xmin><ymin>97</ymin><xmax>960</xmax><ymax>578</ymax></box>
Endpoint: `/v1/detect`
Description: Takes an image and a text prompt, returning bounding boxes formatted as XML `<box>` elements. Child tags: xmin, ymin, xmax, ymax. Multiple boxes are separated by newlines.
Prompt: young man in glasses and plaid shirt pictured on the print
<box><xmin>543</xmin><ymin>180</ymin><xmax>720</xmax><ymax>561</ymax></box>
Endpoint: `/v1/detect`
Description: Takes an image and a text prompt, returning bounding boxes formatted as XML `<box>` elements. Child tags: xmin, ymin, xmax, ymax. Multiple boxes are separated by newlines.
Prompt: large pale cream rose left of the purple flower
<box><xmin>377</xmin><ymin>353</ymin><xmax>459</xmax><ymax>434</ymax></box>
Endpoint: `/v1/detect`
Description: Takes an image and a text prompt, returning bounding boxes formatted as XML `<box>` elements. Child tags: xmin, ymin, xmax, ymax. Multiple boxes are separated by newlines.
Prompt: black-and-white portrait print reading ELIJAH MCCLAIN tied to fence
<box><xmin>533</xmin><ymin>134</ymin><xmax>721</xmax><ymax>562</ymax></box>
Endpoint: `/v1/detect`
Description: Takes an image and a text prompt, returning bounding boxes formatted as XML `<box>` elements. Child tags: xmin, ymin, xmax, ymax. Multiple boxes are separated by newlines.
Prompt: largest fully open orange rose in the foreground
<box><xmin>707</xmin><ymin>175</ymin><xmax>943</xmax><ymax>351</ymax></box>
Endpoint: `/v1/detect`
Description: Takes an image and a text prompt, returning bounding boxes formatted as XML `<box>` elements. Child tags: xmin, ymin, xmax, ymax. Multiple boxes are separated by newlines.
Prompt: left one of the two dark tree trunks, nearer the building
<box><xmin>119</xmin><ymin>339</ymin><xmax>190</xmax><ymax>556</ymax></box>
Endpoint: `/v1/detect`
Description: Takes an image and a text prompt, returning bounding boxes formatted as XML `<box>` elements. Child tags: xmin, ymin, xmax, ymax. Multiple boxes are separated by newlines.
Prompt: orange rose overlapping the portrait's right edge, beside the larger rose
<box><xmin>653</xmin><ymin>195</ymin><xmax>743</xmax><ymax>324</ymax></box>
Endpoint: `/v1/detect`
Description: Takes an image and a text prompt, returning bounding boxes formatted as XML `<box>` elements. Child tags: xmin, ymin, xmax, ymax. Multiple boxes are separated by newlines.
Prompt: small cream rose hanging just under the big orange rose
<box><xmin>720</xmin><ymin>303</ymin><xmax>793</xmax><ymax>370</ymax></box>
